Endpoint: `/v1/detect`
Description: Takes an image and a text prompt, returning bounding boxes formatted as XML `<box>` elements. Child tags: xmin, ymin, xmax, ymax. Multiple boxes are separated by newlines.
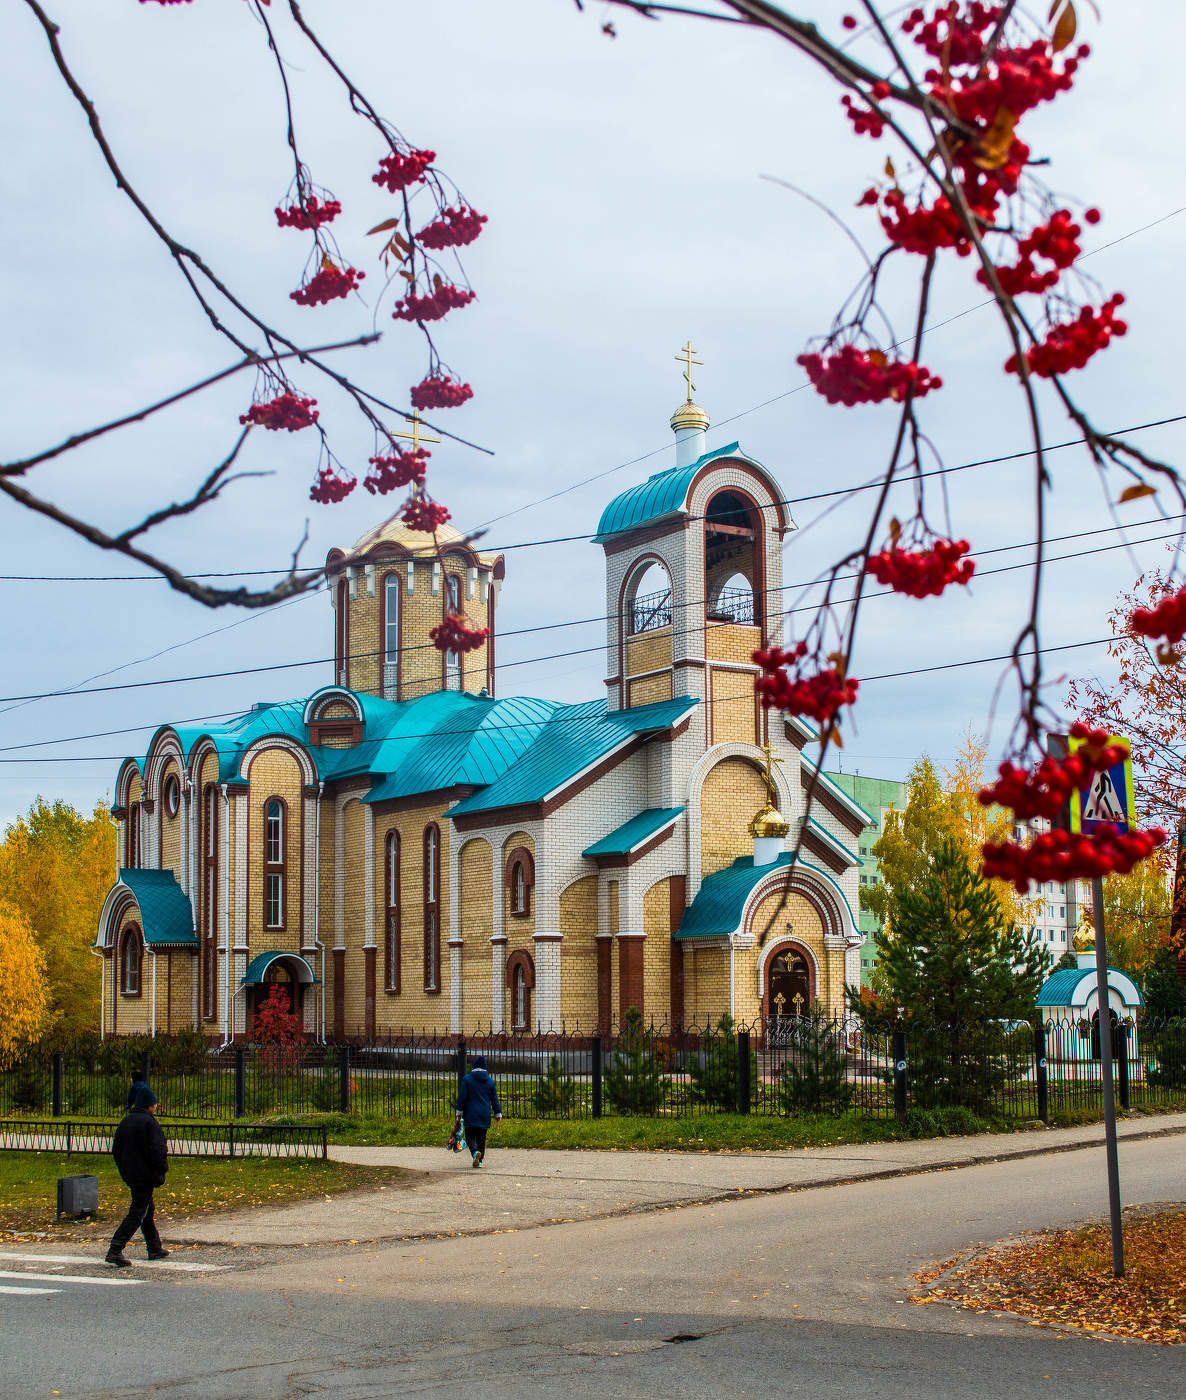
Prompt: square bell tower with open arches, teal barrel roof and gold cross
<box><xmin>595</xmin><ymin>340</ymin><xmax>795</xmax><ymax>746</ymax></box>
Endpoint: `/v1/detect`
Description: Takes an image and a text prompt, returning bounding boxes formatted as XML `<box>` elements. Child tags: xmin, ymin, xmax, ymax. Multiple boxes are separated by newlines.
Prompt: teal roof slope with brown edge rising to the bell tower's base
<box><xmin>445</xmin><ymin>696</ymin><xmax>700</xmax><ymax>816</ymax></box>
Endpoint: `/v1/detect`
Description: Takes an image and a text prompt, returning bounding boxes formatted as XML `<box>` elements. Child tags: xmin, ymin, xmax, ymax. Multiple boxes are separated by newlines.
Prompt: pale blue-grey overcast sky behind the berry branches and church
<box><xmin>0</xmin><ymin>0</ymin><xmax>1186</xmax><ymax>823</ymax></box>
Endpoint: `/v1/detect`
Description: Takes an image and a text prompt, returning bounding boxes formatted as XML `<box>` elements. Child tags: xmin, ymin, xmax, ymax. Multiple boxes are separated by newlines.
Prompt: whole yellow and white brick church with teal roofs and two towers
<box><xmin>92</xmin><ymin>361</ymin><xmax>872</xmax><ymax>1043</ymax></box>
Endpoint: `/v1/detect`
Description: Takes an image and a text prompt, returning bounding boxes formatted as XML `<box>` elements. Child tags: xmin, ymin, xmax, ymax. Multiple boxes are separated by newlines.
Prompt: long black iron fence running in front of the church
<box><xmin>0</xmin><ymin>1016</ymin><xmax>1186</xmax><ymax>1125</ymax></box>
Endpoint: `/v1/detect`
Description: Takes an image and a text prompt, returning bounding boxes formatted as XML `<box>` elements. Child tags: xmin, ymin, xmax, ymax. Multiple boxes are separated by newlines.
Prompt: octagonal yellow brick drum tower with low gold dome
<box><xmin>325</xmin><ymin>518</ymin><xmax>505</xmax><ymax>700</ymax></box>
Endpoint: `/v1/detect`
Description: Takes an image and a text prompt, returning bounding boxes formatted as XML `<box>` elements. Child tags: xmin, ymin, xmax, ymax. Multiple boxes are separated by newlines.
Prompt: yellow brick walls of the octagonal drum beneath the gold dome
<box><xmin>349</xmin><ymin>550</ymin><xmax>487</xmax><ymax>700</ymax></box>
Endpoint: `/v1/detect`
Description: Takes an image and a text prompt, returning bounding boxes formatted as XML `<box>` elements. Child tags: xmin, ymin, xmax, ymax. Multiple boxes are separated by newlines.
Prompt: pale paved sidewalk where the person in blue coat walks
<box><xmin>171</xmin><ymin>1113</ymin><xmax>1186</xmax><ymax>1246</ymax></box>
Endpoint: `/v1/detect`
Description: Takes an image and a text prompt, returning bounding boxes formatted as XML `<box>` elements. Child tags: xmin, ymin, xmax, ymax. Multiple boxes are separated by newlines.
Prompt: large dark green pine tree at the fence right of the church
<box><xmin>850</xmin><ymin>837</ymin><xmax>1050</xmax><ymax>1107</ymax></box>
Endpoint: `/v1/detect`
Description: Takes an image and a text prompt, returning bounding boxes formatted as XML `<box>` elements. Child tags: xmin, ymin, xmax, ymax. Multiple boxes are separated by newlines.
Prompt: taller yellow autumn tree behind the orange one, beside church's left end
<box><xmin>0</xmin><ymin>798</ymin><xmax>115</xmax><ymax>1039</ymax></box>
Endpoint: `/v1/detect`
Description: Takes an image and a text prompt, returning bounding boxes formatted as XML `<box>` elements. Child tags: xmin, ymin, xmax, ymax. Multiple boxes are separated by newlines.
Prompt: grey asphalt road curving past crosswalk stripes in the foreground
<box><xmin>0</xmin><ymin>1137</ymin><xmax>1186</xmax><ymax>1400</ymax></box>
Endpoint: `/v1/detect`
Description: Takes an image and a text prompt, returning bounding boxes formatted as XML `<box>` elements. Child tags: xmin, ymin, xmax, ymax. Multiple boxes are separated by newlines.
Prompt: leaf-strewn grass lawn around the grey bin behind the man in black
<box><xmin>0</xmin><ymin>1152</ymin><xmax>407</xmax><ymax>1235</ymax></box>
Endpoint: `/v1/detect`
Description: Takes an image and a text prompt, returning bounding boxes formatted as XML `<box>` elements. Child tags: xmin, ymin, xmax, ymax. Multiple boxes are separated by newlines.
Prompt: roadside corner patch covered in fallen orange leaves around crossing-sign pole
<box><xmin>914</xmin><ymin>1208</ymin><xmax>1186</xmax><ymax>1345</ymax></box>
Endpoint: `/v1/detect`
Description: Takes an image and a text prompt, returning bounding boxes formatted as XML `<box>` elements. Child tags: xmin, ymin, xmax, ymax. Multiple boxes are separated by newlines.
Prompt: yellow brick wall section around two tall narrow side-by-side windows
<box><xmin>372</xmin><ymin>800</ymin><xmax>451</xmax><ymax>1033</ymax></box>
